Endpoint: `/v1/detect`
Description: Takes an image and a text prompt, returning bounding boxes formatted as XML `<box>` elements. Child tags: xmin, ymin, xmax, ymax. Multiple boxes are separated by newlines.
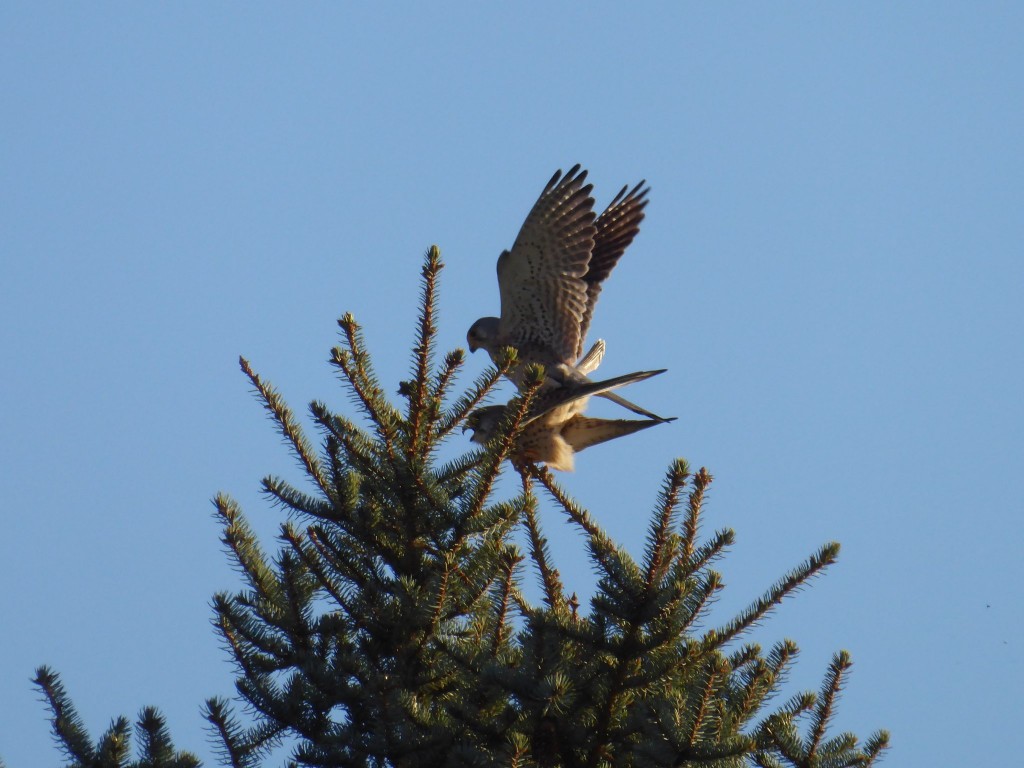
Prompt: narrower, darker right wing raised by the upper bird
<box><xmin>577</xmin><ymin>181</ymin><xmax>650</xmax><ymax>356</ymax></box>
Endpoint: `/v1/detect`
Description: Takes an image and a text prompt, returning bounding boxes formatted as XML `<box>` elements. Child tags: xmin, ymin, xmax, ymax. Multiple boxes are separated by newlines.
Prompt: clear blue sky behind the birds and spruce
<box><xmin>0</xmin><ymin>1</ymin><xmax>1024</xmax><ymax>768</ymax></box>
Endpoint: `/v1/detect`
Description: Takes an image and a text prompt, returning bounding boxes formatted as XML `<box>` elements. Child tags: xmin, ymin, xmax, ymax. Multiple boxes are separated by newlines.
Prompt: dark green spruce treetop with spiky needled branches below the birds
<box><xmin>36</xmin><ymin>248</ymin><xmax>888</xmax><ymax>768</ymax></box>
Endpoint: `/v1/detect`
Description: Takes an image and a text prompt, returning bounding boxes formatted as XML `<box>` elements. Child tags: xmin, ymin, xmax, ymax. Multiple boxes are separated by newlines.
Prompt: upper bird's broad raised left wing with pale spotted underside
<box><xmin>498</xmin><ymin>165</ymin><xmax>595</xmax><ymax>366</ymax></box>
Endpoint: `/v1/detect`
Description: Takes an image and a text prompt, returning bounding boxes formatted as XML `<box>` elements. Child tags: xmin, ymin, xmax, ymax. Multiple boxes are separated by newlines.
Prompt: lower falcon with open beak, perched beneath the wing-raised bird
<box><xmin>463</xmin><ymin>370</ymin><xmax>665</xmax><ymax>472</ymax></box>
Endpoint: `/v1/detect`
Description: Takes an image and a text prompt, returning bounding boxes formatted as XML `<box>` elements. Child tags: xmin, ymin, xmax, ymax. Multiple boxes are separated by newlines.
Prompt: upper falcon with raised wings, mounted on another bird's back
<box><xmin>466</xmin><ymin>165</ymin><xmax>664</xmax><ymax>421</ymax></box>
